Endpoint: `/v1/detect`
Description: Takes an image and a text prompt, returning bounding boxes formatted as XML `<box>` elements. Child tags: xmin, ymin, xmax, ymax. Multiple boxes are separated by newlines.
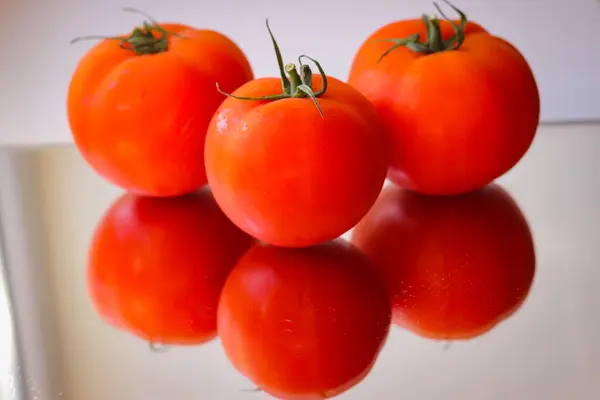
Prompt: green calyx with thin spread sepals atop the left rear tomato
<box><xmin>71</xmin><ymin>7</ymin><xmax>179</xmax><ymax>55</ymax></box>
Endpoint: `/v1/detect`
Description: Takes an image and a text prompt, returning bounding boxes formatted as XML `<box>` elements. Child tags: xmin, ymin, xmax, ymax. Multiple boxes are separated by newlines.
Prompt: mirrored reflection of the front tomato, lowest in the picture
<box><xmin>218</xmin><ymin>239</ymin><xmax>391</xmax><ymax>400</ymax></box>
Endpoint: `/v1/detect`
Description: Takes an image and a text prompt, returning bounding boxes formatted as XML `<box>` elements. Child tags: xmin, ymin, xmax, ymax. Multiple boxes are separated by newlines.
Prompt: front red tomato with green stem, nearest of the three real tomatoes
<box><xmin>205</xmin><ymin>21</ymin><xmax>387</xmax><ymax>247</ymax></box>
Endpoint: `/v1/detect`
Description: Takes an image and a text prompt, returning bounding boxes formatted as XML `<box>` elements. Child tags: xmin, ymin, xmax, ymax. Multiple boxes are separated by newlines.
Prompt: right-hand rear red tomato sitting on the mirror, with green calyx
<box><xmin>348</xmin><ymin>1</ymin><xmax>540</xmax><ymax>195</ymax></box>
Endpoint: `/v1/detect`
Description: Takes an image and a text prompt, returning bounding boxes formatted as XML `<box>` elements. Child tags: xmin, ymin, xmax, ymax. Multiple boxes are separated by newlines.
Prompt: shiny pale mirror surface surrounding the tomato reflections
<box><xmin>5</xmin><ymin>124</ymin><xmax>600</xmax><ymax>400</ymax></box>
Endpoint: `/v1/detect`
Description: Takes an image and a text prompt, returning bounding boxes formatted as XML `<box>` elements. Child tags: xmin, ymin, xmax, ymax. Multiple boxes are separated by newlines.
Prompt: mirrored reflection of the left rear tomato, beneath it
<box><xmin>88</xmin><ymin>188</ymin><xmax>254</xmax><ymax>345</ymax></box>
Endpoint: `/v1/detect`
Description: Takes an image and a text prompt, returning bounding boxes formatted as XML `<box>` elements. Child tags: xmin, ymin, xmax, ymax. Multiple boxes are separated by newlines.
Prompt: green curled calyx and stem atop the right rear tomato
<box><xmin>378</xmin><ymin>0</ymin><xmax>467</xmax><ymax>62</ymax></box>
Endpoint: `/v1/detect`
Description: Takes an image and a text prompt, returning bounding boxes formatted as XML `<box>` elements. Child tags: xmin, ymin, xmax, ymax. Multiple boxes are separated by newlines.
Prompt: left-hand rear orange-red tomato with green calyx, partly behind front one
<box><xmin>67</xmin><ymin>8</ymin><xmax>254</xmax><ymax>196</ymax></box>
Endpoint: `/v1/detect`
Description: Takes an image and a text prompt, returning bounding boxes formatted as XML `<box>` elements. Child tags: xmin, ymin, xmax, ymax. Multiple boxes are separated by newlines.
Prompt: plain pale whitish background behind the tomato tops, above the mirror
<box><xmin>0</xmin><ymin>0</ymin><xmax>600</xmax><ymax>145</ymax></box>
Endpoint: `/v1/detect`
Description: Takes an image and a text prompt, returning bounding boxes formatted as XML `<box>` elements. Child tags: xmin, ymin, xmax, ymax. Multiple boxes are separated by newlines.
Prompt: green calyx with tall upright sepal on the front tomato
<box><xmin>217</xmin><ymin>20</ymin><xmax>327</xmax><ymax>118</ymax></box>
